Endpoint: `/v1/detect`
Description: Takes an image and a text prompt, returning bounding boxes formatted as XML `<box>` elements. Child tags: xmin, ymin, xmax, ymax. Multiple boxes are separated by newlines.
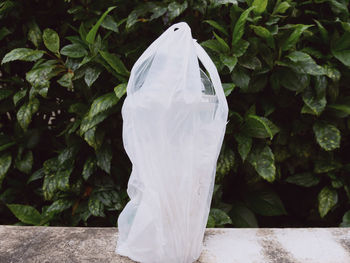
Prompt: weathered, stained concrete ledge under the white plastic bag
<box><xmin>0</xmin><ymin>226</ymin><xmax>350</xmax><ymax>263</ymax></box>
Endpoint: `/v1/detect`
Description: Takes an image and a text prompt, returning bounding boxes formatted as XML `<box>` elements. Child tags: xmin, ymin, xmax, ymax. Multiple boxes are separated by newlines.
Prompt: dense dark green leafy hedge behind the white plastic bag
<box><xmin>0</xmin><ymin>0</ymin><xmax>350</xmax><ymax>227</ymax></box>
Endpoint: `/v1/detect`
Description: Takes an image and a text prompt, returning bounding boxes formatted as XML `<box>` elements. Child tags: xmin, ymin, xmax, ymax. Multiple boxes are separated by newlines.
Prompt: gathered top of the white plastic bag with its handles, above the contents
<box><xmin>127</xmin><ymin>22</ymin><xmax>228</xmax><ymax>120</ymax></box>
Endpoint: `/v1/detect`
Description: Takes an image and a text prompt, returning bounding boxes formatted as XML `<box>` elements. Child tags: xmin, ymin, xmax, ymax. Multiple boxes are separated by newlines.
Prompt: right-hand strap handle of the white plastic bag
<box><xmin>193</xmin><ymin>39</ymin><xmax>228</xmax><ymax>119</ymax></box>
